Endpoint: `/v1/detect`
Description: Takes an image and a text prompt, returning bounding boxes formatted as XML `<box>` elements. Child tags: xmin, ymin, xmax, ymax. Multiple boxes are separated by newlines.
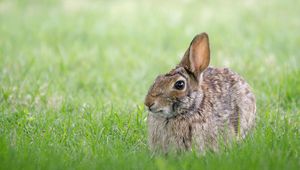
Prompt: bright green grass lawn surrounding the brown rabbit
<box><xmin>0</xmin><ymin>0</ymin><xmax>300</xmax><ymax>170</ymax></box>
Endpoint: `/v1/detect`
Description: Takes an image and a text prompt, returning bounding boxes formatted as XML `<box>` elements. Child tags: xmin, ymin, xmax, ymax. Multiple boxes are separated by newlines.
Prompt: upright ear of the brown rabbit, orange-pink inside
<box><xmin>179</xmin><ymin>33</ymin><xmax>210</xmax><ymax>79</ymax></box>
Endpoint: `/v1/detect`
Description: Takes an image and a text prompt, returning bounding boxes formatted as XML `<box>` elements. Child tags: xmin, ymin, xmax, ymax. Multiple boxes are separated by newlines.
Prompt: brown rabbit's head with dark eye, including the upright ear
<box><xmin>145</xmin><ymin>33</ymin><xmax>210</xmax><ymax>117</ymax></box>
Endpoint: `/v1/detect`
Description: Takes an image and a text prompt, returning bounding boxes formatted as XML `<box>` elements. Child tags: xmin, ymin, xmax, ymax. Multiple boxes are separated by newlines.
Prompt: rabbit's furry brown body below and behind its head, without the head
<box><xmin>148</xmin><ymin>67</ymin><xmax>256</xmax><ymax>152</ymax></box>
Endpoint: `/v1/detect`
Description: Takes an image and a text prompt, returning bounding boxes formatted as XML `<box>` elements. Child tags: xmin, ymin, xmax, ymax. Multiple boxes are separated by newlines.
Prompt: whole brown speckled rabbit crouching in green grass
<box><xmin>145</xmin><ymin>33</ymin><xmax>256</xmax><ymax>153</ymax></box>
